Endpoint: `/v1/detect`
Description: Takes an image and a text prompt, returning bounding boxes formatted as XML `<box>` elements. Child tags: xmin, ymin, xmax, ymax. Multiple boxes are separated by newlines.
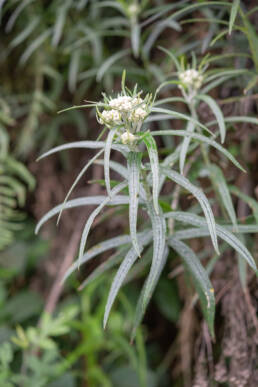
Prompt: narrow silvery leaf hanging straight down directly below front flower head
<box><xmin>127</xmin><ymin>152</ymin><xmax>142</xmax><ymax>256</ymax></box>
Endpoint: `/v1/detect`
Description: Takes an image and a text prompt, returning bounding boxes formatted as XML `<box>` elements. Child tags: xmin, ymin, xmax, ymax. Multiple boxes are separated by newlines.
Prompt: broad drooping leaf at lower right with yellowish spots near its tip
<box><xmin>168</xmin><ymin>237</ymin><xmax>215</xmax><ymax>337</ymax></box>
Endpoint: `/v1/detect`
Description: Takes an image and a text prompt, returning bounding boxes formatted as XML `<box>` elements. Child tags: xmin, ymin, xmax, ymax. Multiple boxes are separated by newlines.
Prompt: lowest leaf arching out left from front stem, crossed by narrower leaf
<box><xmin>63</xmin><ymin>234</ymin><xmax>131</xmax><ymax>282</ymax></box>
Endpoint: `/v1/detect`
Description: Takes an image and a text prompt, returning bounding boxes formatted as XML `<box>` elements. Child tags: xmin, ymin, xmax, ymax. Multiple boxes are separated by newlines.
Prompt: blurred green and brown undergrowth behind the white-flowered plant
<box><xmin>0</xmin><ymin>0</ymin><xmax>258</xmax><ymax>387</ymax></box>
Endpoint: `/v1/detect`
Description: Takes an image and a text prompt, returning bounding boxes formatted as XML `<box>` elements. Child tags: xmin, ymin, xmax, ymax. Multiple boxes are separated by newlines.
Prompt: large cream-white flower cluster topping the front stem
<box><xmin>99</xmin><ymin>95</ymin><xmax>148</xmax><ymax>126</ymax></box>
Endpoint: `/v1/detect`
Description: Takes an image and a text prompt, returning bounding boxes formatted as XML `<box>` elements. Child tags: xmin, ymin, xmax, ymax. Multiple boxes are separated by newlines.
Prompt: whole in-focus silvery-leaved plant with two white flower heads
<box><xmin>37</xmin><ymin>68</ymin><xmax>257</xmax><ymax>338</ymax></box>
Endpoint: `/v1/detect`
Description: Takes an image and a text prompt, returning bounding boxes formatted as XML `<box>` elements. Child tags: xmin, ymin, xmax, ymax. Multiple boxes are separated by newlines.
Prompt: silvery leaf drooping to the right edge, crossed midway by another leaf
<box><xmin>164</xmin><ymin>211</ymin><xmax>257</xmax><ymax>272</ymax></box>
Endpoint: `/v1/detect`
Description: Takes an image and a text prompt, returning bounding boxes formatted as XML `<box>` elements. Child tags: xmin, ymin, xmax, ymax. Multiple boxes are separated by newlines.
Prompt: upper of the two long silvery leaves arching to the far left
<box><xmin>37</xmin><ymin>141</ymin><xmax>129</xmax><ymax>160</ymax></box>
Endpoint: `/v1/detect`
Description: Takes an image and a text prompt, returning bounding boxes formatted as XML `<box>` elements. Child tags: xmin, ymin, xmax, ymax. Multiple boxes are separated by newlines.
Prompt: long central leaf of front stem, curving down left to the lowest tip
<box><xmin>131</xmin><ymin>202</ymin><xmax>168</xmax><ymax>340</ymax></box>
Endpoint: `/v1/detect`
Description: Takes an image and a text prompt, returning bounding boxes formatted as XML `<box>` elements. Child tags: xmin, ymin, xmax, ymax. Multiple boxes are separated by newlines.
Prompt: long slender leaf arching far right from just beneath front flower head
<box><xmin>151</xmin><ymin>130</ymin><xmax>246</xmax><ymax>172</ymax></box>
